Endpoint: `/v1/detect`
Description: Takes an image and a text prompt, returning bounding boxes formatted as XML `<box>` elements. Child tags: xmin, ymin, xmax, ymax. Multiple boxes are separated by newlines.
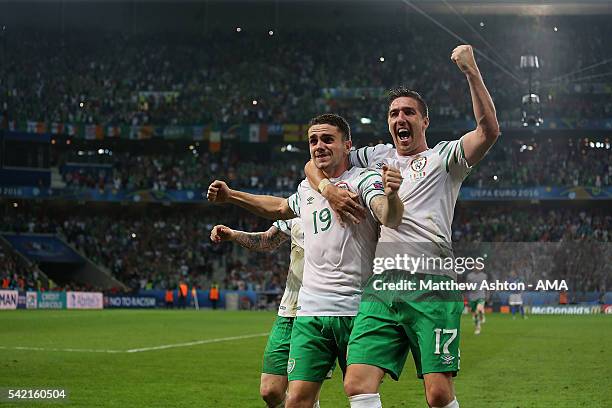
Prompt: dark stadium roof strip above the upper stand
<box><xmin>0</xmin><ymin>0</ymin><xmax>612</xmax><ymax>32</ymax></box>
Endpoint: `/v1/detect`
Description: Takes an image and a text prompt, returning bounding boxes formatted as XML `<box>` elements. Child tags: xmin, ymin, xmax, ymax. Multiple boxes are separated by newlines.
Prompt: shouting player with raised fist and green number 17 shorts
<box><xmin>306</xmin><ymin>45</ymin><xmax>499</xmax><ymax>408</ymax></box>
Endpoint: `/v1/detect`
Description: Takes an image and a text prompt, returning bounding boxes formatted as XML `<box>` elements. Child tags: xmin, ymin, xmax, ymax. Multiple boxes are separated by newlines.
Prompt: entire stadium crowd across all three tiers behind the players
<box><xmin>0</xmin><ymin>17</ymin><xmax>612</xmax><ymax>296</ymax></box>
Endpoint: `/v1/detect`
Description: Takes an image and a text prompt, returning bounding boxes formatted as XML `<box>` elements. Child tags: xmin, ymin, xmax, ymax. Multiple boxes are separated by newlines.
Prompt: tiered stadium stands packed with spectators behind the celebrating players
<box><xmin>0</xmin><ymin>16</ymin><xmax>612</xmax><ymax>300</ymax></box>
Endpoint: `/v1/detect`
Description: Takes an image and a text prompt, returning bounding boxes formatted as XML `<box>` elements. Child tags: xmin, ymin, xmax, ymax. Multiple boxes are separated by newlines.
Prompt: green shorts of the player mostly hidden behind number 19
<box><xmin>261</xmin><ymin>316</ymin><xmax>295</xmax><ymax>375</ymax></box>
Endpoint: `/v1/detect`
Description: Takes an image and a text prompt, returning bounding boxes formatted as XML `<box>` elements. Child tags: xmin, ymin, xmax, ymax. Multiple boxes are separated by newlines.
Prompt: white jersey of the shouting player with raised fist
<box><xmin>350</xmin><ymin>138</ymin><xmax>471</xmax><ymax>278</ymax></box>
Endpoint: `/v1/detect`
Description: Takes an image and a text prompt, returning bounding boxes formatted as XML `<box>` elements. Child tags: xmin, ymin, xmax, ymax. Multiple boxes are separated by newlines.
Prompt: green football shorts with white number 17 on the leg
<box><xmin>348</xmin><ymin>271</ymin><xmax>463</xmax><ymax>380</ymax></box>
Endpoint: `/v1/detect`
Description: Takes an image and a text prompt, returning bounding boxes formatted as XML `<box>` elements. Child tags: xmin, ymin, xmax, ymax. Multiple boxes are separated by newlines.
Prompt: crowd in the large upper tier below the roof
<box><xmin>0</xmin><ymin>17</ymin><xmax>612</xmax><ymax>128</ymax></box>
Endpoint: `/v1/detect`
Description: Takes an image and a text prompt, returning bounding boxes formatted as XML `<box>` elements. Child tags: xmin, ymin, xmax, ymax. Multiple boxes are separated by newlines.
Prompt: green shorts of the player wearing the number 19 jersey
<box><xmin>286</xmin><ymin>316</ymin><xmax>354</xmax><ymax>382</ymax></box>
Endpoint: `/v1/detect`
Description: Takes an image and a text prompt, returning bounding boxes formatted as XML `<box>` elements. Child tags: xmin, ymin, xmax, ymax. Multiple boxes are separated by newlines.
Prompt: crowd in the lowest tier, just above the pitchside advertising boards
<box><xmin>0</xmin><ymin>206</ymin><xmax>612</xmax><ymax>291</ymax></box>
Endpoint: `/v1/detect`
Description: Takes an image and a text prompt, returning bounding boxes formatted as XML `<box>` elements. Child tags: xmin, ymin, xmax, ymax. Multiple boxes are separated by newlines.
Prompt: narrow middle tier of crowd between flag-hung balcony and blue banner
<box><xmin>58</xmin><ymin>137</ymin><xmax>612</xmax><ymax>191</ymax></box>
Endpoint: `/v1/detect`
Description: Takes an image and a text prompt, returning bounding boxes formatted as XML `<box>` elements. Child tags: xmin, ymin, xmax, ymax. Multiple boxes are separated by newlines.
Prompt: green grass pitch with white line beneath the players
<box><xmin>0</xmin><ymin>310</ymin><xmax>612</xmax><ymax>408</ymax></box>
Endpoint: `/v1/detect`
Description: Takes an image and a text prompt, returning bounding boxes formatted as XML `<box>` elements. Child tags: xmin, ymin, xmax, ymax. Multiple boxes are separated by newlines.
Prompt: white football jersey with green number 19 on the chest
<box><xmin>287</xmin><ymin>167</ymin><xmax>384</xmax><ymax>316</ymax></box>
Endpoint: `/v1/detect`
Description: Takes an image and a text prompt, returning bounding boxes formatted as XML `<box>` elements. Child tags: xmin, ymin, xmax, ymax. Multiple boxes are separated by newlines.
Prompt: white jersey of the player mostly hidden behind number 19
<box><xmin>273</xmin><ymin>218</ymin><xmax>304</xmax><ymax>317</ymax></box>
